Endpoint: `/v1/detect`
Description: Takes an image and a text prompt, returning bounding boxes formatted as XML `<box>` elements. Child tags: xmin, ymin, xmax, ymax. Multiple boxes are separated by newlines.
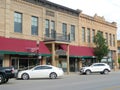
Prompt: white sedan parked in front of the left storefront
<box><xmin>17</xmin><ymin>65</ymin><xmax>64</xmax><ymax>80</ymax></box>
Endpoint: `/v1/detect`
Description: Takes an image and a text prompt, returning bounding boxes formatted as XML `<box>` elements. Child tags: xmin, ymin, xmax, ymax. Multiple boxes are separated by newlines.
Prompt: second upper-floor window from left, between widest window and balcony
<box><xmin>31</xmin><ymin>16</ymin><xmax>38</xmax><ymax>35</ymax></box>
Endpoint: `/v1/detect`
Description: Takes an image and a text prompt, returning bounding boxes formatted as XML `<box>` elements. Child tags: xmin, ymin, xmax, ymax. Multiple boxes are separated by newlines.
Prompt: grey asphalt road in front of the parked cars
<box><xmin>0</xmin><ymin>71</ymin><xmax>120</xmax><ymax>90</ymax></box>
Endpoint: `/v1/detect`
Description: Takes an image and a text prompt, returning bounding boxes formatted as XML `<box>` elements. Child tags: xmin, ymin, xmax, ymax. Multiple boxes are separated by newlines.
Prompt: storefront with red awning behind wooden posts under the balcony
<box><xmin>47</xmin><ymin>41</ymin><xmax>95</xmax><ymax>74</ymax></box>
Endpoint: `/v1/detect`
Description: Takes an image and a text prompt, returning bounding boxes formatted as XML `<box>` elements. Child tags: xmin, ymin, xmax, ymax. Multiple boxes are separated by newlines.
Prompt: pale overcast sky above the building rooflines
<box><xmin>48</xmin><ymin>0</ymin><xmax>120</xmax><ymax>40</ymax></box>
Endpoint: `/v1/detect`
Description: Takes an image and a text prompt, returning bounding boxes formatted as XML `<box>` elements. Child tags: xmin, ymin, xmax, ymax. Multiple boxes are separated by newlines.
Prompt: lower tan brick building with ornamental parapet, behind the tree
<box><xmin>79</xmin><ymin>14</ymin><xmax>118</xmax><ymax>68</ymax></box>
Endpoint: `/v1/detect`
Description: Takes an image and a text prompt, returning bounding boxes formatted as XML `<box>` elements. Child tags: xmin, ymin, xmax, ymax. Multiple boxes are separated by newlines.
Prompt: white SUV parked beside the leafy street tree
<box><xmin>80</xmin><ymin>63</ymin><xmax>111</xmax><ymax>74</ymax></box>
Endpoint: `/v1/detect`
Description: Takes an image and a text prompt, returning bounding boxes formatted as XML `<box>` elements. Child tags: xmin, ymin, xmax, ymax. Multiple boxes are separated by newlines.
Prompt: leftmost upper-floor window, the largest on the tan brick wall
<box><xmin>14</xmin><ymin>12</ymin><xmax>22</xmax><ymax>33</ymax></box>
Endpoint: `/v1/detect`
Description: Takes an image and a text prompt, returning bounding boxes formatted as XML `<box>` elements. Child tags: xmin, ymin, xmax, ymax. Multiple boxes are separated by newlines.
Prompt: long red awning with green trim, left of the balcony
<box><xmin>0</xmin><ymin>37</ymin><xmax>50</xmax><ymax>55</ymax></box>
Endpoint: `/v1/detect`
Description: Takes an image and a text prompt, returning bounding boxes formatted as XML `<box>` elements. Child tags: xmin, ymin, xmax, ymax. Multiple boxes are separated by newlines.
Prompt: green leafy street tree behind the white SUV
<box><xmin>94</xmin><ymin>32</ymin><xmax>109</xmax><ymax>62</ymax></box>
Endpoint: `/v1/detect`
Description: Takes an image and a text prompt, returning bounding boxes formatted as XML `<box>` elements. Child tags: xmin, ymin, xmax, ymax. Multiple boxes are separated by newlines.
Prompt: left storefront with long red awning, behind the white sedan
<box><xmin>0</xmin><ymin>37</ymin><xmax>51</xmax><ymax>69</ymax></box>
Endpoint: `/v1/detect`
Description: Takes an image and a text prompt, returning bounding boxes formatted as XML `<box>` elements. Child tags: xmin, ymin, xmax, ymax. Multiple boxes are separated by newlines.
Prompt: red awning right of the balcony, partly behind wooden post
<box><xmin>61</xmin><ymin>45</ymin><xmax>94</xmax><ymax>56</ymax></box>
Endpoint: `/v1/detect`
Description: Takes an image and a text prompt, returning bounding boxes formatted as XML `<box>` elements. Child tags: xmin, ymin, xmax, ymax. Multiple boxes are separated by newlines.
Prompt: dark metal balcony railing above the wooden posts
<box><xmin>44</xmin><ymin>33</ymin><xmax>70</xmax><ymax>42</ymax></box>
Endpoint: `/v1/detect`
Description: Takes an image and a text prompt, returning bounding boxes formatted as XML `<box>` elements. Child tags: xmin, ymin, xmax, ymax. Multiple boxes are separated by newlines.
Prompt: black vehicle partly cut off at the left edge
<box><xmin>0</xmin><ymin>67</ymin><xmax>14</xmax><ymax>84</ymax></box>
